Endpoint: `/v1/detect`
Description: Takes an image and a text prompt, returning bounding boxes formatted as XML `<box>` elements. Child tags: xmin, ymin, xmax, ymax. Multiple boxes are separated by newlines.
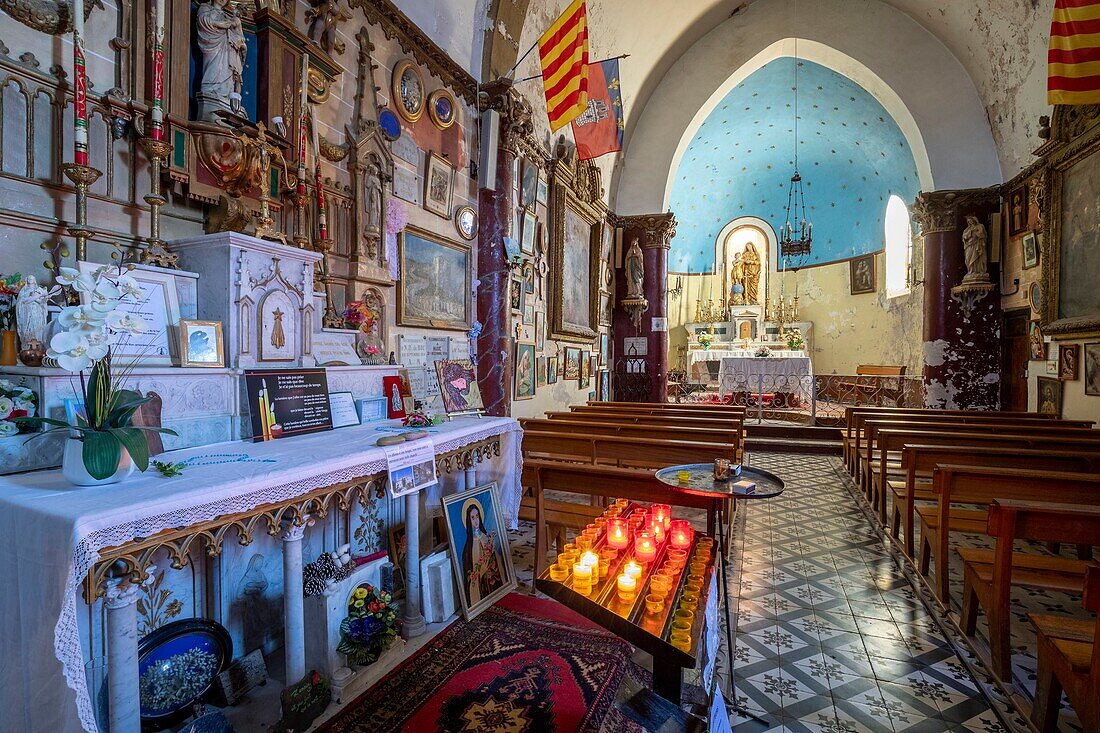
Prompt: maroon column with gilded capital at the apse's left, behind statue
<box><xmin>613</xmin><ymin>211</ymin><xmax>677</xmax><ymax>402</ymax></box>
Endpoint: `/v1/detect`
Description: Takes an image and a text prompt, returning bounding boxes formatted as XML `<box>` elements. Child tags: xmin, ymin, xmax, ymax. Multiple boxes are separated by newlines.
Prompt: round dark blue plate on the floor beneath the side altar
<box><xmin>138</xmin><ymin>619</ymin><xmax>233</xmax><ymax>730</ymax></box>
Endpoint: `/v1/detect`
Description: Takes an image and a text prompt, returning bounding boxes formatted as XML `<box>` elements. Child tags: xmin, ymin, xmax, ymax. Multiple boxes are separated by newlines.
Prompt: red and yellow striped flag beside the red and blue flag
<box><xmin>539</xmin><ymin>0</ymin><xmax>589</xmax><ymax>131</ymax></box>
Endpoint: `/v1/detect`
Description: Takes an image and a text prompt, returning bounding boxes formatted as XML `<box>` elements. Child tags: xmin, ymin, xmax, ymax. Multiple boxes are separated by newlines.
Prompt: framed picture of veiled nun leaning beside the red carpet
<box><xmin>443</xmin><ymin>482</ymin><xmax>516</xmax><ymax>621</ymax></box>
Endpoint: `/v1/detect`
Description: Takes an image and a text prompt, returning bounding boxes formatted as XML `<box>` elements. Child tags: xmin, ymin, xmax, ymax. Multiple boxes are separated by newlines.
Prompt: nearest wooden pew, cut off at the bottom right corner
<box><xmin>1027</xmin><ymin>559</ymin><xmax>1100</xmax><ymax>733</ymax></box>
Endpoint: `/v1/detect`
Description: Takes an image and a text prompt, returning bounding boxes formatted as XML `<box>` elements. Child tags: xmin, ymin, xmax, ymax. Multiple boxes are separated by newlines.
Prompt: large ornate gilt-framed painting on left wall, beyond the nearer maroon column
<box><xmin>548</xmin><ymin>161</ymin><xmax>606</xmax><ymax>343</ymax></box>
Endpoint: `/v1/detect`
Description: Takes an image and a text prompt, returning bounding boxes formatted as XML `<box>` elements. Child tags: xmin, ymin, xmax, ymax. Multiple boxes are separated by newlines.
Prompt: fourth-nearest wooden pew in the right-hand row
<box><xmin>887</xmin><ymin>442</ymin><xmax>1100</xmax><ymax>559</ymax></box>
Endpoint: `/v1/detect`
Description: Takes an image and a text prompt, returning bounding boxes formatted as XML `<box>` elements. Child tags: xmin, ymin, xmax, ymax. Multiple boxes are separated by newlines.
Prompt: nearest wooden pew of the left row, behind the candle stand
<box><xmin>524</xmin><ymin>460</ymin><xmax>724</xmax><ymax>576</ymax></box>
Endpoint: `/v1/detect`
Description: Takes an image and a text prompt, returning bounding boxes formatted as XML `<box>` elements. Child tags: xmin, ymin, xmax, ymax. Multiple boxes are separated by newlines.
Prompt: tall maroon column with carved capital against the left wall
<box><xmin>473</xmin><ymin>79</ymin><xmax>534</xmax><ymax>413</ymax></box>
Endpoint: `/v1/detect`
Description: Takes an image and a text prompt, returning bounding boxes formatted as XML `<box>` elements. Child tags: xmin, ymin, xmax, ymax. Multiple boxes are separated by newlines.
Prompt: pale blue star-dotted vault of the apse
<box><xmin>669</xmin><ymin>57</ymin><xmax>921</xmax><ymax>272</ymax></box>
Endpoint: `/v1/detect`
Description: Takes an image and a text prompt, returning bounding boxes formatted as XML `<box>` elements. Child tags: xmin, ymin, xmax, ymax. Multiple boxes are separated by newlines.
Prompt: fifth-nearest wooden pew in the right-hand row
<box><xmin>859</xmin><ymin>417</ymin><xmax>1100</xmax><ymax>501</ymax></box>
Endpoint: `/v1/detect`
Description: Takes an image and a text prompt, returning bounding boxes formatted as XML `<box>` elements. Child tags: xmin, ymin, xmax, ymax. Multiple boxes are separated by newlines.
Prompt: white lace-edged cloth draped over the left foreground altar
<box><xmin>0</xmin><ymin>417</ymin><xmax>523</xmax><ymax>733</ymax></box>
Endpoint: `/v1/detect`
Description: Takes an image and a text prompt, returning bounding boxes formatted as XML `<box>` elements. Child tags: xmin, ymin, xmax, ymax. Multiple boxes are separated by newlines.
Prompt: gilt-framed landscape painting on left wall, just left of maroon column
<box><xmin>397</xmin><ymin>226</ymin><xmax>473</xmax><ymax>331</ymax></box>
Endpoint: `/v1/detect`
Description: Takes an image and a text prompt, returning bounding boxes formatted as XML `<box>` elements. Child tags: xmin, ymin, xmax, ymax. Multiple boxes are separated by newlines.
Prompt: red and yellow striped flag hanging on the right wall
<box><xmin>1046</xmin><ymin>0</ymin><xmax>1100</xmax><ymax>105</ymax></box>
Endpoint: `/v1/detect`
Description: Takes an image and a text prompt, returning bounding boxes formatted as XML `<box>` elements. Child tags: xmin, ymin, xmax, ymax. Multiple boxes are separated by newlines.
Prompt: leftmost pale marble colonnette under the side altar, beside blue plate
<box><xmin>103</xmin><ymin>578</ymin><xmax>141</xmax><ymax>733</ymax></box>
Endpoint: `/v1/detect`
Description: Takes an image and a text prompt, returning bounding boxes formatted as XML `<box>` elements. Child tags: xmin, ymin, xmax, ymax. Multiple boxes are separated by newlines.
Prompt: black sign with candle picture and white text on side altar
<box><xmin>244</xmin><ymin>369</ymin><xmax>332</xmax><ymax>441</ymax></box>
